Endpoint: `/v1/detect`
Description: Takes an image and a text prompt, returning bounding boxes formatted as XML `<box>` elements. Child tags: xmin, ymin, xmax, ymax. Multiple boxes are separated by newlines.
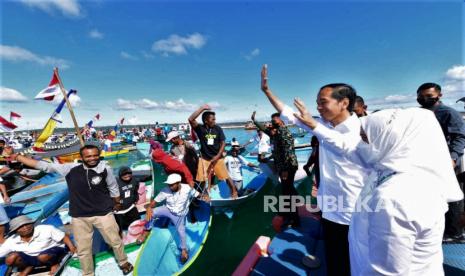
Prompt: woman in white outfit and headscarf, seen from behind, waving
<box><xmin>295</xmin><ymin>104</ymin><xmax>463</xmax><ymax>276</ymax></box>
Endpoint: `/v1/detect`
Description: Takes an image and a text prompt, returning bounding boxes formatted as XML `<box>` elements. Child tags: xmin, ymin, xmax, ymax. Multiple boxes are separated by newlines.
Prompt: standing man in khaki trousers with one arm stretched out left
<box><xmin>12</xmin><ymin>145</ymin><xmax>134</xmax><ymax>276</ymax></box>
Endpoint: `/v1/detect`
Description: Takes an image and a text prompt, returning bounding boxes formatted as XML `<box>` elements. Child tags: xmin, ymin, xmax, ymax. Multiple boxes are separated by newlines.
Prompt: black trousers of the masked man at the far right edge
<box><xmin>444</xmin><ymin>173</ymin><xmax>465</xmax><ymax>237</ymax></box>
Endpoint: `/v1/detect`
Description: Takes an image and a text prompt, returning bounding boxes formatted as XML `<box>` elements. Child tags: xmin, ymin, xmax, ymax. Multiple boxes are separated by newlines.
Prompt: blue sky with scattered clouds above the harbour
<box><xmin>0</xmin><ymin>0</ymin><xmax>465</xmax><ymax>128</ymax></box>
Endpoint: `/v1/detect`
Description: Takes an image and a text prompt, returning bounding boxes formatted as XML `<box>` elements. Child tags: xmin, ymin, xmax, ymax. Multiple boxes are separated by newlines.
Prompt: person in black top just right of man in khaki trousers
<box><xmin>115</xmin><ymin>166</ymin><xmax>140</xmax><ymax>235</ymax></box>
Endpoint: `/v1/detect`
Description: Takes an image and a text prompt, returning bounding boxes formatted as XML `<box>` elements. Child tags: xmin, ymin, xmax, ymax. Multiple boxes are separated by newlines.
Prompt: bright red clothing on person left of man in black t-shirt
<box><xmin>152</xmin><ymin>141</ymin><xmax>194</xmax><ymax>188</ymax></box>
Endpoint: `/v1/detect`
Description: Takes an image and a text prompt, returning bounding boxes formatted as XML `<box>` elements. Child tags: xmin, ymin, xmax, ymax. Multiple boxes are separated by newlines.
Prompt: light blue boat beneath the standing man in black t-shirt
<box><xmin>210</xmin><ymin>167</ymin><xmax>267</xmax><ymax>207</ymax></box>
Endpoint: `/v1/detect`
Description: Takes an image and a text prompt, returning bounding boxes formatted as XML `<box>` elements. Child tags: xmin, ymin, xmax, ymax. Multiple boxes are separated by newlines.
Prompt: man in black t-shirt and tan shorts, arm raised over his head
<box><xmin>189</xmin><ymin>105</ymin><xmax>237</xmax><ymax>198</ymax></box>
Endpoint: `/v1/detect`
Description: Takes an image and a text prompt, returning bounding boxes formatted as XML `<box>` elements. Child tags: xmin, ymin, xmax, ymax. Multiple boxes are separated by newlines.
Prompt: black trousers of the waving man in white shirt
<box><xmin>321</xmin><ymin>218</ymin><xmax>350</xmax><ymax>276</ymax></box>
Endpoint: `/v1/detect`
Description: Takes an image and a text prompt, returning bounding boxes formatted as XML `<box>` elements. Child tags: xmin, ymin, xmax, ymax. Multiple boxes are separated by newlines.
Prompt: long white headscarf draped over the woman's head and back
<box><xmin>361</xmin><ymin>108</ymin><xmax>463</xmax><ymax>202</ymax></box>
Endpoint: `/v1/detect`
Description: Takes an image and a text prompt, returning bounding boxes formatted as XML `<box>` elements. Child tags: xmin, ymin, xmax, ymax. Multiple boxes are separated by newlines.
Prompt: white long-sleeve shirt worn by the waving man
<box><xmin>281</xmin><ymin>106</ymin><xmax>369</xmax><ymax>225</ymax></box>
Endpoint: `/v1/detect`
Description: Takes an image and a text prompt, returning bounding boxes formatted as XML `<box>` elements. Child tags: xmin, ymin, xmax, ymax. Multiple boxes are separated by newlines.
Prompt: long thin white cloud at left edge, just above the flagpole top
<box><xmin>0</xmin><ymin>45</ymin><xmax>69</xmax><ymax>69</ymax></box>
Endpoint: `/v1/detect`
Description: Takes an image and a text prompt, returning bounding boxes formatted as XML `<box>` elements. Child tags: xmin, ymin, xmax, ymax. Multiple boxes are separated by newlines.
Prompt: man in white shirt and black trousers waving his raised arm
<box><xmin>261</xmin><ymin>66</ymin><xmax>367</xmax><ymax>276</ymax></box>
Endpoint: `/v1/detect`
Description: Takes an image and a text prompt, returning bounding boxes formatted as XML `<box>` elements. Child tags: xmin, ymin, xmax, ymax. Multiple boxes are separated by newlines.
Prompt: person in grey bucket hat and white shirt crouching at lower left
<box><xmin>0</xmin><ymin>215</ymin><xmax>76</xmax><ymax>275</ymax></box>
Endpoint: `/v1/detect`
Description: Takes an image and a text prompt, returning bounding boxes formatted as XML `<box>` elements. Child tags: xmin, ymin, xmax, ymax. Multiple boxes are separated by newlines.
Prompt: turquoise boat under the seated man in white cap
<box><xmin>134</xmin><ymin>201</ymin><xmax>212</xmax><ymax>276</ymax></box>
